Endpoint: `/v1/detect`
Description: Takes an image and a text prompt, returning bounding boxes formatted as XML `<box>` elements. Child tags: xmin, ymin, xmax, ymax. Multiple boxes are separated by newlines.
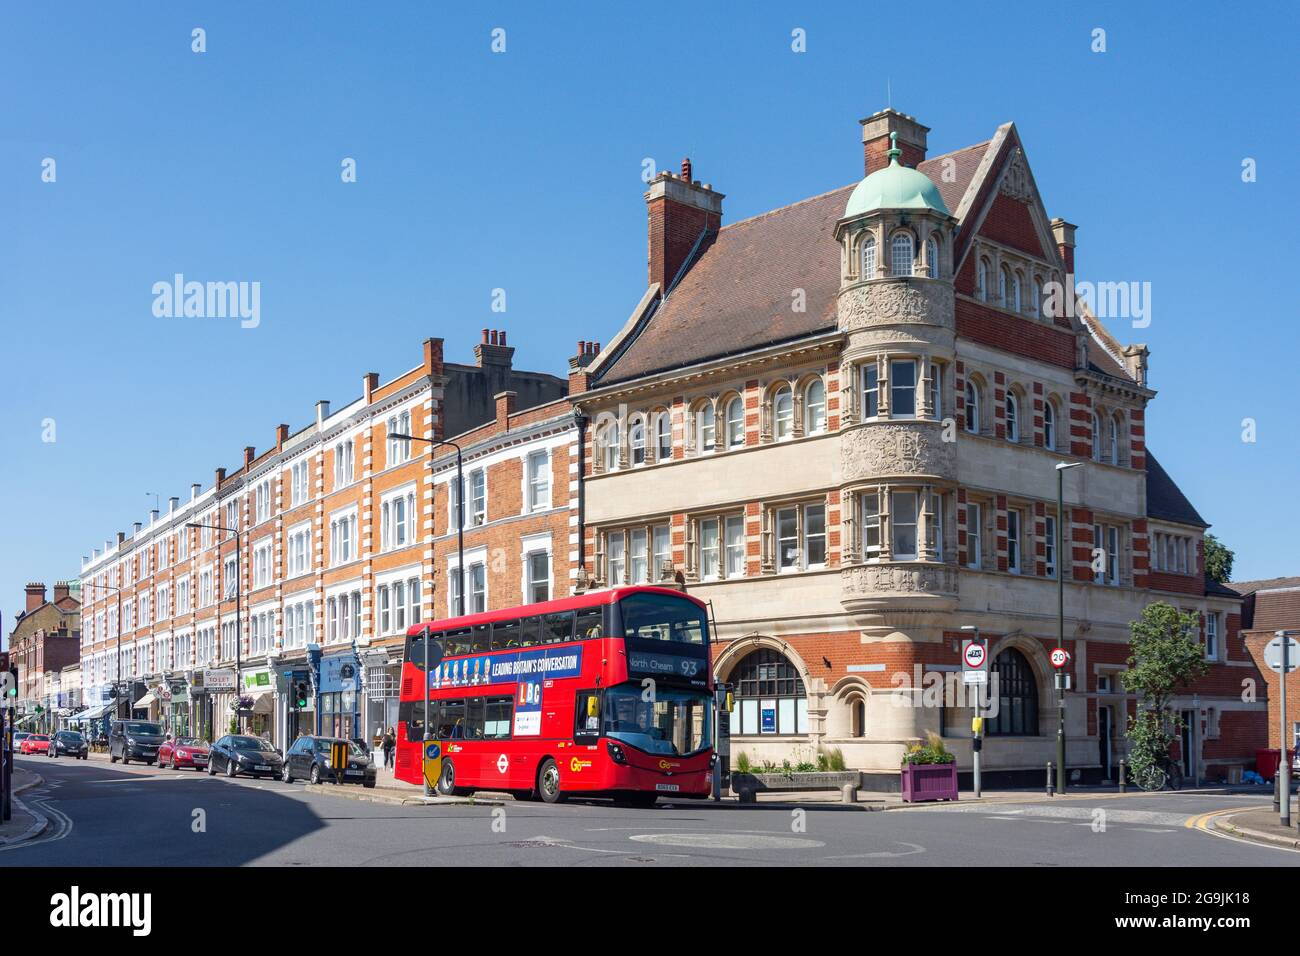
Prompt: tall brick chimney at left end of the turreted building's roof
<box><xmin>645</xmin><ymin>159</ymin><xmax>725</xmax><ymax>294</ymax></box>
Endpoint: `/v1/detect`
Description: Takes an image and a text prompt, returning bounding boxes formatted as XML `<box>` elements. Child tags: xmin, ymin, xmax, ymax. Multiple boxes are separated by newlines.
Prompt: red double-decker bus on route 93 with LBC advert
<box><xmin>397</xmin><ymin>587</ymin><xmax>714</xmax><ymax>804</ymax></box>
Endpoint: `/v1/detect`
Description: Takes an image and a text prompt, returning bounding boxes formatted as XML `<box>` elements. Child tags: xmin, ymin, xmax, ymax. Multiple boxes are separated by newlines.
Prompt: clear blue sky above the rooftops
<box><xmin>0</xmin><ymin>1</ymin><xmax>1300</xmax><ymax>631</ymax></box>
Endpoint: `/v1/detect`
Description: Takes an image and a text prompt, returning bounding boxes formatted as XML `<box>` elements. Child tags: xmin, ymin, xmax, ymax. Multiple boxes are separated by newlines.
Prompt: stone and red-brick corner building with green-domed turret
<box><xmin>569</xmin><ymin>109</ymin><xmax>1266</xmax><ymax>788</ymax></box>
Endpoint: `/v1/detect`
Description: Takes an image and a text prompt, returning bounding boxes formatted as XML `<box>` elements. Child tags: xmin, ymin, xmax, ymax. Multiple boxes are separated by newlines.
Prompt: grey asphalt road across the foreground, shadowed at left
<box><xmin>0</xmin><ymin>757</ymin><xmax>1300</xmax><ymax>868</ymax></box>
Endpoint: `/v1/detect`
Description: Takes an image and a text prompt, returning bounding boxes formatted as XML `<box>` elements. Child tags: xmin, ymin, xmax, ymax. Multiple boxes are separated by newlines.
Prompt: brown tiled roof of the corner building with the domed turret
<box><xmin>599</xmin><ymin>143</ymin><xmax>988</xmax><ymax>385</ymax></box>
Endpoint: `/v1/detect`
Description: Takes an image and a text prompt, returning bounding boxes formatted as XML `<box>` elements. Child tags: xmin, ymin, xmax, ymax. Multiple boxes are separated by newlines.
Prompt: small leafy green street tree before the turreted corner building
<box><xmin>1119</xmin><ymin>601</ymin><xmax>1209</xmax><ymax>780</ymax></box>
